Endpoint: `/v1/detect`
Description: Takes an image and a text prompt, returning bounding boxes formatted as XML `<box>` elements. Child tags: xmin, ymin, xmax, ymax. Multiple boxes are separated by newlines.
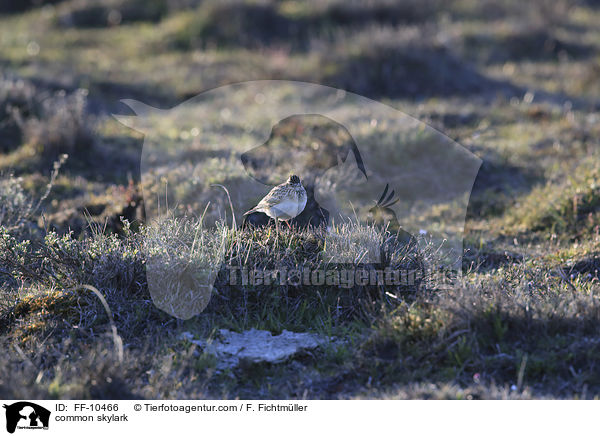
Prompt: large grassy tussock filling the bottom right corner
<box><xmin>354</xmin><ymin>265</ymin><xmax>600</xmax><ymax>397</ymax></box>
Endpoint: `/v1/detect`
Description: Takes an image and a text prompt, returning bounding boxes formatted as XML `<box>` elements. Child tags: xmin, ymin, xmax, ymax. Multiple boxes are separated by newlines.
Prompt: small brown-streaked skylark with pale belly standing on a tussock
<box><xmin>244</xmin><ymin>175</ymin><xmax>306</xmax><ymax>232</ymax></box>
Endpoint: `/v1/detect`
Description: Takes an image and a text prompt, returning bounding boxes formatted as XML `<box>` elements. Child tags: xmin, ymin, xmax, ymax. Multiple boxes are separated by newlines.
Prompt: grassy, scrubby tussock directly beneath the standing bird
<box><xmin>142</xmin><ymin>218</ymin><xmax>426</xmax><ymax>331</ymax></box>
